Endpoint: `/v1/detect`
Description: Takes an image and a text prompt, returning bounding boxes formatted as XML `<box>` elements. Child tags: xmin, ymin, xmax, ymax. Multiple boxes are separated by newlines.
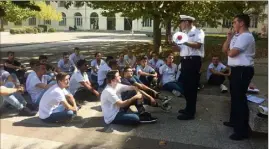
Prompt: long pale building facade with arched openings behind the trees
<box><xmin>1</xmin><ymin>1</ymin><xmax>268</xmax><ymax>33</ymax></box>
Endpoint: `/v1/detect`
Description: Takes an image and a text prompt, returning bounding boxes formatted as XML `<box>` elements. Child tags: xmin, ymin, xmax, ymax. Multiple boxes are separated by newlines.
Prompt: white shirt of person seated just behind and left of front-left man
<box><xmin>26</xmin><ymin>71</ymin><xmax>52</xmax><ymax>102</ymax></box>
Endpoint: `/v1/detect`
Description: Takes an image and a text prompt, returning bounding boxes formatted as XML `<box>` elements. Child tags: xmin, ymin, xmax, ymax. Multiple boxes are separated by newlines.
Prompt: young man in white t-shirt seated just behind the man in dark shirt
<box><xmin>136</xmin><ymin>56</ymin><xmax>158</xmax><ymax>87</ymax></box>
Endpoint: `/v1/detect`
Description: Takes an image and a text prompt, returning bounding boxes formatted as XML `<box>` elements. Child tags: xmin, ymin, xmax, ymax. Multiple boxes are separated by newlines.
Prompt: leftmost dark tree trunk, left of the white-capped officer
<box><xmin>153</xmin><ymin>15</ymin><xmax>162</xmax><ymax>53</ymax></box>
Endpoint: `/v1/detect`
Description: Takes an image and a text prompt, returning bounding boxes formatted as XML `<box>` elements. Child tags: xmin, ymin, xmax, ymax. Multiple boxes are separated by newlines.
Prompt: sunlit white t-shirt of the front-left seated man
<box><xmin>38</xmin><ymin>84</ymin><xmax>68</xmax><ymax>119</ymax></box>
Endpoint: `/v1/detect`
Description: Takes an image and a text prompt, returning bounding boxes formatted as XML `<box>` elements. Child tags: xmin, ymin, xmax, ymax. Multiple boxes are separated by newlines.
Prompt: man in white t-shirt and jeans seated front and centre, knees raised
<box><xmin>101</xmin><ymin>70</ymin><xmax>157</xmax><ymax>125</ymax></box>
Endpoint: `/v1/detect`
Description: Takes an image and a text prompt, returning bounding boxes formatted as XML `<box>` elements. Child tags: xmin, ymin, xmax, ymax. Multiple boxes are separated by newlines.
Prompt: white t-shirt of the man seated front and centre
<box><xmin>100</xmin><ymin>83</ymin><xmax>132</xmax><ymax>124</ymax></box>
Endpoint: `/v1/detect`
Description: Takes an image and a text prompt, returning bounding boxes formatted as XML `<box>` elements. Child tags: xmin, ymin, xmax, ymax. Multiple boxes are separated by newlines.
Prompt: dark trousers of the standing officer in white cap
<box><xmin>181</xmin><ymin>56</ymin><xmax>202</xmax><ymax>116</ymax></box>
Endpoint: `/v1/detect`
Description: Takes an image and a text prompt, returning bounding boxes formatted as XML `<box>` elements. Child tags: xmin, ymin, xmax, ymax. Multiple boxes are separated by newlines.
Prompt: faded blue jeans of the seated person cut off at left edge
<box><xmin>2</xmin><ymin>82</ymin><xmax>27</xmax><ymax>110</ymax></box>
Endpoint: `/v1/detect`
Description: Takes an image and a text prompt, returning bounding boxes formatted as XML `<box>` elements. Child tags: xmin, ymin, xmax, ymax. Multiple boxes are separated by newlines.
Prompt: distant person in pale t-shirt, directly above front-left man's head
<box><xmin>57</xmin><ymin>52</ymin><xmax>74</xmax><ymax>75</ymax></box>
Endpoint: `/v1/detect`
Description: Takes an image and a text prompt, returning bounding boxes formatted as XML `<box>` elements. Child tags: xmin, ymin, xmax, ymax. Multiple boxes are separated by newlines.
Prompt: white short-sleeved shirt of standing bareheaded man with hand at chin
<box><xmin>228</xmin><ymin>32</ymin><xmax>255</xmax><ymax>66</ymax></box>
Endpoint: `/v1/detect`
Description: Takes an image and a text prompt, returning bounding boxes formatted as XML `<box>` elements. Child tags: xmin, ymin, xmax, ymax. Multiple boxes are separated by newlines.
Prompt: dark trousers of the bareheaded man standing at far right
<box><xmin>230</xmin><ymin>66</ymin><xmax>254</xmax><ymax>135</ymax></box>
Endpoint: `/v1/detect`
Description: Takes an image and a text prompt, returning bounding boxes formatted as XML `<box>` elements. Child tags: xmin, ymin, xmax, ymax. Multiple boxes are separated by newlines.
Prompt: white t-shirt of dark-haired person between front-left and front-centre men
<box><xmin>69</xmin><ymin>70</ymin><xmax>89</xmax><ymax>95</ymax></box>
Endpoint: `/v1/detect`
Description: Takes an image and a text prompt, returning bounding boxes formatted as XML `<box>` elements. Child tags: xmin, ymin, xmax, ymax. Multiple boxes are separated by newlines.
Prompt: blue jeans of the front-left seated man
<box><xmin>42</xmin><ymin>105</ymin><xmax>76</xmax><ymax>123</ymax></box>
